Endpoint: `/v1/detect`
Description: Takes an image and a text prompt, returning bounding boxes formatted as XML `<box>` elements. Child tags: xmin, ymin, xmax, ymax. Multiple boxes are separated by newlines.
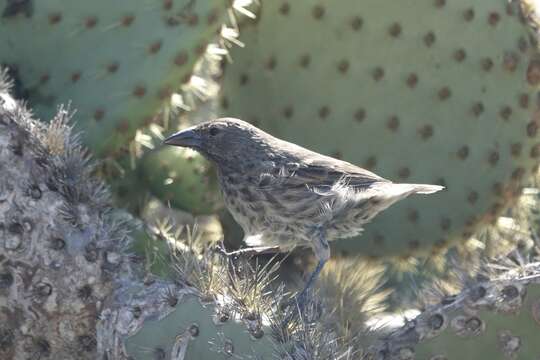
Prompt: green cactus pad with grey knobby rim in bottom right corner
<box><xmin>372</xmin><ymin>262</ymin><xmax>540</xmax><ymax>360</ymax></box>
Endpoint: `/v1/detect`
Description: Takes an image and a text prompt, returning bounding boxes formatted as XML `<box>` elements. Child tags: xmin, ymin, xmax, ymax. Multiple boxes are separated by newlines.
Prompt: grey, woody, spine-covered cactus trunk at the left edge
<box><xmin>0</xmin><ymin>73</ymin><xmax>134</xmax><ymax>360</ymax></box>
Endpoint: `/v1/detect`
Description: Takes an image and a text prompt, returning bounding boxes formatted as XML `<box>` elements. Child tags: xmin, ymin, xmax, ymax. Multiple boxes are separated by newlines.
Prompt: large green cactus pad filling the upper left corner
<box><xmin>0</xmin><ymin>0</ymin><xmax>228</xmax><ymax>156</ymax></box>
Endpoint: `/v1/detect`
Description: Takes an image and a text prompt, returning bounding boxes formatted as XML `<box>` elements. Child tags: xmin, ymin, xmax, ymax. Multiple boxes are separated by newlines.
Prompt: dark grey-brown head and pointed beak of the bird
<box><xmin>164</xmin><ymin>118</ymin><xmax>272</xmax><ymax>165</ymax></box>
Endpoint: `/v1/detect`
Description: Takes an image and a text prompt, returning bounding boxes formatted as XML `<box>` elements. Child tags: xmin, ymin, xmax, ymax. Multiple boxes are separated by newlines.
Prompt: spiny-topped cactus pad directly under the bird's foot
<box><xmin>97</xmin><ymin>224</ymin><xmax>368</xmax><ymax>359</ymax></box>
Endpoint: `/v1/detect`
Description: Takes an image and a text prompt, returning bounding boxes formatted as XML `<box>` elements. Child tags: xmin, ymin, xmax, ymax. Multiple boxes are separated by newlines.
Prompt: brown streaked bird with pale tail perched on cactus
<box><xmin>165</xmin><ymin>118</ymin><xmax>443</xmax><ymax>298</ymax></box>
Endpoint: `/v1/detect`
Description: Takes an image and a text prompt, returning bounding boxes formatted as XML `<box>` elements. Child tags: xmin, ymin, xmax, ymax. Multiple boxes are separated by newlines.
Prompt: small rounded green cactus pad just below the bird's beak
<box><xmin>140</xmin><ymin>147</ymin><xmax>221</xmax><ymax>214</ymax></box>
